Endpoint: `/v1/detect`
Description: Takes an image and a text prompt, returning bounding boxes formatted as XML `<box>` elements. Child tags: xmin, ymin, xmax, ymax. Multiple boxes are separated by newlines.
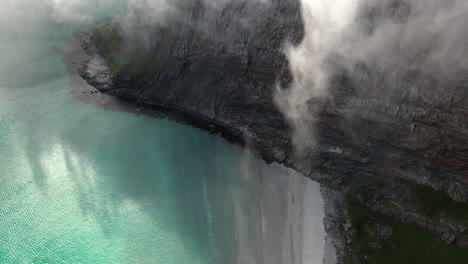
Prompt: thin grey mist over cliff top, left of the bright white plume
<box><xmin>114</xmin><ymin>0</ymin><xmax>270</xmax><ymax>50</ymax></box>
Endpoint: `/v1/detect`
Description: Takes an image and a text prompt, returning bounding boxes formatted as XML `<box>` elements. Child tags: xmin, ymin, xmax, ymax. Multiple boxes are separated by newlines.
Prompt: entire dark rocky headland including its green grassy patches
<box><xmin>75</xmin><ymin>0</ymin><xmax>468</xmax><ymax>263</ymax></box>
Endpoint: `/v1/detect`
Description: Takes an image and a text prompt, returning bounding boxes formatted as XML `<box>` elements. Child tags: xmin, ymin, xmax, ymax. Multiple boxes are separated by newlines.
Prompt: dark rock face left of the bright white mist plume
<box><xmin>80</xmin><ymin>0</ymin><xmax>302</xmax><ymax>159</ymax></box>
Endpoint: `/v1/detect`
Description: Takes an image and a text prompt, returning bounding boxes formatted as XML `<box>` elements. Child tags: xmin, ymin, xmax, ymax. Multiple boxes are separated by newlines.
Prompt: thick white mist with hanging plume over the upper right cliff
<box><xmin>275</xmin><ymin>0</ymin><xmax>468</xmax><ymax>155</ymax></box>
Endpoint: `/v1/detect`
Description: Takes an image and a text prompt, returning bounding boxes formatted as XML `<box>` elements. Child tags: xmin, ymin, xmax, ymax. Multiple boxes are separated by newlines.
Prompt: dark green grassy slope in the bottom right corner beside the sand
<box><xmin>346</xmin><ymin>202</ymin><xmax>468</xmax><ymax>264</ymax></box>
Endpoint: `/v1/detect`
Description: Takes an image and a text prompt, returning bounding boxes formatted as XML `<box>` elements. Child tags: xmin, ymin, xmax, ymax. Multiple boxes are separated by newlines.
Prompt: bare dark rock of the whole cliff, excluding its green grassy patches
<box><xmin>80</xmin><ymin>0</ymin><xmax>468</xmax><ymax>258</ymax></box>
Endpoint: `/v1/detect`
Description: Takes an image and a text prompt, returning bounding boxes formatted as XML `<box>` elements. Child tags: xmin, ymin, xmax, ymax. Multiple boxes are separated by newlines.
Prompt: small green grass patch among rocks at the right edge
<box><xmin>408</xmin><ymin>182</ymin><xmax>468</xmax><ymax>226</ymax></box>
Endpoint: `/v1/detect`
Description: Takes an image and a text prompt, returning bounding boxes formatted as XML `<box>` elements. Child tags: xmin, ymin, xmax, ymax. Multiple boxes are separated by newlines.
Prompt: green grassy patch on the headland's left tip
<box><xmin>93</xmin><ymin>24</ymin><xmax>178</xmax><ymax>78</ymax></box>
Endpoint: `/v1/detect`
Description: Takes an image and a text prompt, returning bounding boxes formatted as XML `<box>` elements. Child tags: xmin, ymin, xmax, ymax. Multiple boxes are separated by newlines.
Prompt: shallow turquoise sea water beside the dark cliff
<box><xmin>0</xmin><ymin>0</ymin><xmax>323</xmax><ymax>264</ymax></box>
